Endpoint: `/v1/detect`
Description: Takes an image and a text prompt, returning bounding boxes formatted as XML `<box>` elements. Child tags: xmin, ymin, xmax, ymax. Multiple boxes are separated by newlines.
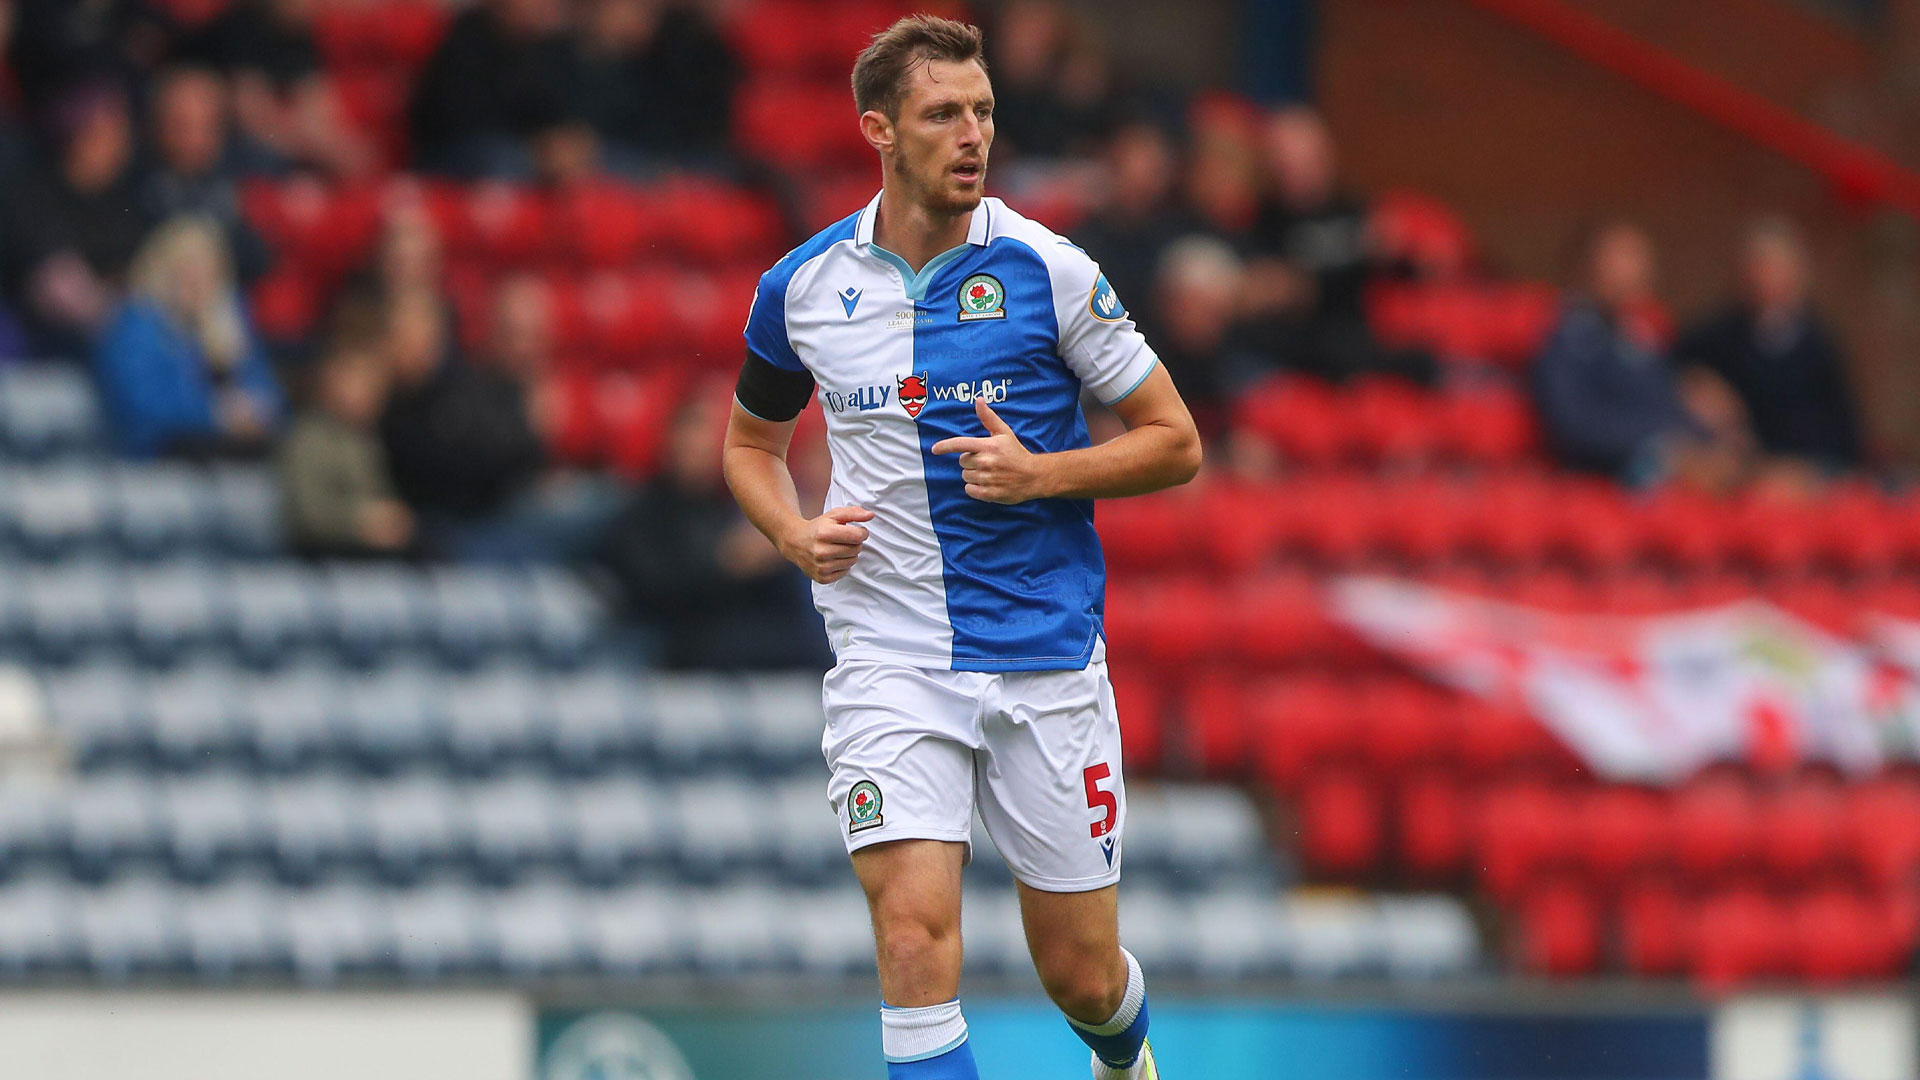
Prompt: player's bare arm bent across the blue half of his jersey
<box><xmin>933</xmin><ymin>357</ymin><xmax>1200</xmax><ymax>503</ymax></box>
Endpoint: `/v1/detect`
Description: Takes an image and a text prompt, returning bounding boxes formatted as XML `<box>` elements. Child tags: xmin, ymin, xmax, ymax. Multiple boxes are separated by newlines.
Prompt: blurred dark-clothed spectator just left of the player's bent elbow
<box><xmin>599</xmin><ymin>390</ymin><xmax>833</xmax><ymax>671</ymax></box>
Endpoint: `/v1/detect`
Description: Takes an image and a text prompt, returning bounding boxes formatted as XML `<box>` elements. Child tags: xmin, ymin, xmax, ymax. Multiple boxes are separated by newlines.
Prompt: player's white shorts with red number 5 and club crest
<box><xmin>820</xmin><ymin>659</ymin><xmax>1127</xmax><ymax>892</ymax></box>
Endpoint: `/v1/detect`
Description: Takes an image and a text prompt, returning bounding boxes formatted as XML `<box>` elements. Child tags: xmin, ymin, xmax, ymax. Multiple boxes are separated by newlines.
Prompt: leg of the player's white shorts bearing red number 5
<box><xmin>975</xmin><ymin>663</ymin><xmax>1127</xmax><ymax>892</ymax></box>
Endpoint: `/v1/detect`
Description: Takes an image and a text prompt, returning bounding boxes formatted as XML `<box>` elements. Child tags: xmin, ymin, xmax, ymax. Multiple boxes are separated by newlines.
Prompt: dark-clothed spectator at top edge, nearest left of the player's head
<box><xmin>566</xmin><ymin>0</ymin><xmax>741</xmax><ymax>173</ymax></box>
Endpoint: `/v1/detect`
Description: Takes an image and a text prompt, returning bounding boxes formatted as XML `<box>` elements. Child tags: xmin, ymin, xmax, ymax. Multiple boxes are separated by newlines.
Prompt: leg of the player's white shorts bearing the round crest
<box><xmin>820</xmin><ymin>663</ymin><xmax>979</xmax><ymax>853</ymax></box>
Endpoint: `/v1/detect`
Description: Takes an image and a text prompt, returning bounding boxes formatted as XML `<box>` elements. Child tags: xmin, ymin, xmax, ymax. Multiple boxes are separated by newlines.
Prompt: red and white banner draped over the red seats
<box><xmin>1329</xmin><ymin>577</ymin><xmax>1920</xmax><ymax>782</ymax></box>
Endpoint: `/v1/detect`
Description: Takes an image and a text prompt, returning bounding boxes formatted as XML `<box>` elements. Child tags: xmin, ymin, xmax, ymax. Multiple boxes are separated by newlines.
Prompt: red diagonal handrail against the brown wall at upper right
<box><xmin>1467</xmin><ymin>0</ymin><xmax>1920</xmax><ymax>219</ymax></box>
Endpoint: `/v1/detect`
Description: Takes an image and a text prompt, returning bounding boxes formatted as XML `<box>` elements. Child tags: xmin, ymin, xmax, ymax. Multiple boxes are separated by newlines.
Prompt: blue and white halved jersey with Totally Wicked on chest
<box><xmin>747</xmin><ymin>196</ymin><xmax>1158</xmax><ymax>671</ymax></box>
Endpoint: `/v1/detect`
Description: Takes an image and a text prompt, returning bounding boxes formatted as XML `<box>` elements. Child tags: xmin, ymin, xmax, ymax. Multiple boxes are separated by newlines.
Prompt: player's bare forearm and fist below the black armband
<box><xmin>722</xmin><ymin>402</ymin><xmax>874</xmax><ymax>584</ymax></box>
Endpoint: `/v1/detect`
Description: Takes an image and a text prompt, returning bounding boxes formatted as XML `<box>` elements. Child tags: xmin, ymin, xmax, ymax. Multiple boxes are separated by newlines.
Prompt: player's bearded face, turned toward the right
<box><xmin>883</xmin><ymin>60</ymin><xmax>993</xmax><ymax>213</ymax></box>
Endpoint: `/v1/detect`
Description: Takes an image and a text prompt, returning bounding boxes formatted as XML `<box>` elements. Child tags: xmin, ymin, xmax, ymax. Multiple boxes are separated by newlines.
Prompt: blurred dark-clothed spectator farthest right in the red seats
<box><xmin>1674</xmin><ymin>219</ymin><xmax>1862</xmax><ymax>472</ymax></box>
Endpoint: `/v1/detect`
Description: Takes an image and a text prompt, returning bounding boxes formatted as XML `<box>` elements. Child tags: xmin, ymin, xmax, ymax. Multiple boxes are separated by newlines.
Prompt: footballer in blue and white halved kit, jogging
<box><xmin>726</xmin><ymin>15</ymin><xmax>1200</xmax><ymax>1080</ymax></box>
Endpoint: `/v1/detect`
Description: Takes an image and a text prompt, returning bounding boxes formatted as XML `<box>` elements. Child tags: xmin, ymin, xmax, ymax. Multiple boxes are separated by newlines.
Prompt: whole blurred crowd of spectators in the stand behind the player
<box><xmin>0</xmin><ymin>0</ymin><xmax>1862</xmax><ymax>667</ymax></box>
